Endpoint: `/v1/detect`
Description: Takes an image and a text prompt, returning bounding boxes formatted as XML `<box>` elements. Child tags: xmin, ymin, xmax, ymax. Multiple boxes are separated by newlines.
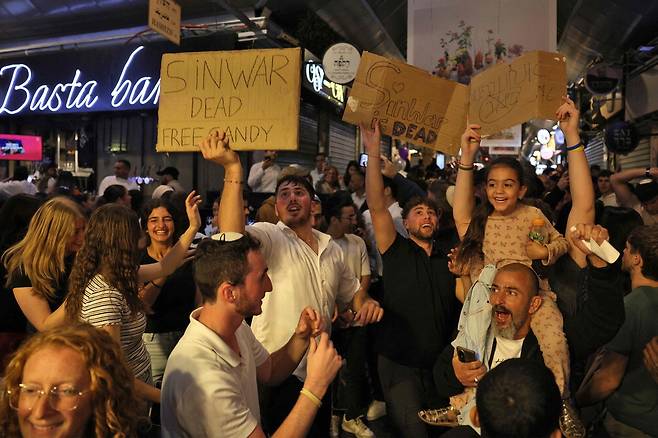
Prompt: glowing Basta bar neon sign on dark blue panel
<box><xmin>0</xmin><ymin>46</ymin><xmax>161</xmax><ymax>115</ymax></box>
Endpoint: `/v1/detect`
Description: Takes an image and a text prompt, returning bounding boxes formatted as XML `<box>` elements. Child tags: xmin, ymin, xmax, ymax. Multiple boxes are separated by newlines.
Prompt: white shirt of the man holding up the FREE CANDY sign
<box><xmin>247</xmin><ymin>221</ymin><xmax>359</xmax><ymax>380</ymax></box>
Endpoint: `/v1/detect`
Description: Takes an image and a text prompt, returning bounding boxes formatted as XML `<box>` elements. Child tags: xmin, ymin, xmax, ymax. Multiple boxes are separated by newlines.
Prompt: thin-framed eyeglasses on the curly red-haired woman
<box><xmin>7</xmin><ymin>383</ymin><xmax>89</xmax><ymax>411</ymax></box>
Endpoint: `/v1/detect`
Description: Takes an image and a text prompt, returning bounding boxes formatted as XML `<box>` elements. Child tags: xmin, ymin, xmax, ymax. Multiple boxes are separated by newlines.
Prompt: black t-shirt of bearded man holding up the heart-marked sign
<box><xmin>376</xmin><ymin>234</ymin><xmax>460</xmax><ymax>368</ymax></box>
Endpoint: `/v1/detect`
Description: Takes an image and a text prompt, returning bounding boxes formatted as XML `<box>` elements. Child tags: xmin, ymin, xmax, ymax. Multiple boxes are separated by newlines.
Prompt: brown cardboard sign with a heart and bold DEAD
<box><xmin>343</xmin><ymin>52</ymin><xmax>468</xmax><ymax>155</ymax></box>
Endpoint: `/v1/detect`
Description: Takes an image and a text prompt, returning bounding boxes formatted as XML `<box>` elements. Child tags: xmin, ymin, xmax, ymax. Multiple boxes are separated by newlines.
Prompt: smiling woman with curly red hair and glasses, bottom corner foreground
<box><xmin>0</xmin><ymin>324</ymin><xmax>138</xmax><ymax>438</ymax></box>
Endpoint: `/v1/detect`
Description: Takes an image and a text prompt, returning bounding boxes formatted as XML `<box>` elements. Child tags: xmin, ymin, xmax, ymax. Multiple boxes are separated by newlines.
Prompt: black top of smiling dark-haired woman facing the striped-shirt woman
<box><xmin>141</xmin><ymin>250</ymin><xmax>196</xmax><ymax>333</ymax></box>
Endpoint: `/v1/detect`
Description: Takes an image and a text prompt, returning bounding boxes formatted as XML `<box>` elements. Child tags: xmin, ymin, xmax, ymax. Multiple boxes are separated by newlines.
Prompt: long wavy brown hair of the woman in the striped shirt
<box><xmin>66</xmin><ymin>204</ymin><xmax>144</xmax><ymax>319</ymax></box>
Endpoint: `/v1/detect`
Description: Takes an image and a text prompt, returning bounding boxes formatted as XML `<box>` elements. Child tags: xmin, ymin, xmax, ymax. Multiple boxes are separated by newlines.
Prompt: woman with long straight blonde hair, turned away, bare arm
<box><xmin>2</xmin><ymin>196</ymin><xmax>86</xmax><ymax>330</ymax></box>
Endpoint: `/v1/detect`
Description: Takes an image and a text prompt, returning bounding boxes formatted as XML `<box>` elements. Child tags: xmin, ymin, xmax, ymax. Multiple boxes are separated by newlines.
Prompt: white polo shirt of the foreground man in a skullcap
<box><xmin>160</xmin><ymin>309</ymin><xmax>269</xmax><ymax>438</ymax></box>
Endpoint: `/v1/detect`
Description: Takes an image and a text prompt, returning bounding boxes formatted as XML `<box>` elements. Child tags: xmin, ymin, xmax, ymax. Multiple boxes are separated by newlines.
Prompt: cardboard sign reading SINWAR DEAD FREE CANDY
<box><xmin>156</xmin><ymin>48</ymin><xmax>301</xmax><ymax>152</ymax></box>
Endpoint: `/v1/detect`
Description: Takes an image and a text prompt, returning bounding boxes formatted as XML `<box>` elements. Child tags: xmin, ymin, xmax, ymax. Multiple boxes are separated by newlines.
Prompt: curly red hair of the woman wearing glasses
<box><xmin>0</xmin><ymin>324</ymin><xmax>138</xmax><ymax>438</ymax></box>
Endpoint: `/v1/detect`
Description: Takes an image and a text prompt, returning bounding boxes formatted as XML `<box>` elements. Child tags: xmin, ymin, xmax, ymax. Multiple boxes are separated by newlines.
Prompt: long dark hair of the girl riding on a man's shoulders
<box><xmin>457</xmin><ymin>157</ymin><xmax>525</xmax><ymax>266</ymax></box>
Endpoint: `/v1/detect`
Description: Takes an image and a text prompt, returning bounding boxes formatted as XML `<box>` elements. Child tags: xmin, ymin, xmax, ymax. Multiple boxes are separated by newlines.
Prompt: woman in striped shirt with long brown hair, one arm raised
<box><xmin>65</xmin><ymin>192</ymin><xmax>201</xmax><ymax>403</ymax></box>
